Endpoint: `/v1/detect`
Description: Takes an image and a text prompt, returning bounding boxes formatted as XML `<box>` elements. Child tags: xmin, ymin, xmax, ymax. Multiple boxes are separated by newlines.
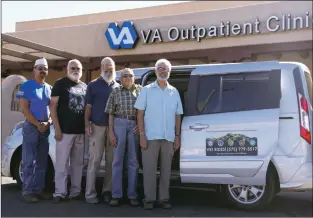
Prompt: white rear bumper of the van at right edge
<box><xmin>280</xmin><ymin>162</ymin><xmax>313</xmax><ymax>191</ymax></box>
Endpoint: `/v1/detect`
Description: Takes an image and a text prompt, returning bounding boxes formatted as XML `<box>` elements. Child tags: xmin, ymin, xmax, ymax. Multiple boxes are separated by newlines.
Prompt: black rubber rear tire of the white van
<box><xmin>223</xmin><ymin>164</ymin><xmax>279</xmax><ymax>211</ymax></box>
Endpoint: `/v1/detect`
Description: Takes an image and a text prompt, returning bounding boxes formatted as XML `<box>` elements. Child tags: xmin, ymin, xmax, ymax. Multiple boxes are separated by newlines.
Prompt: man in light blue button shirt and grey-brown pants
<box><xmin>135</xmin><ymin>59</ymin><xmax>183</xmax><ymax>209</ymax></box>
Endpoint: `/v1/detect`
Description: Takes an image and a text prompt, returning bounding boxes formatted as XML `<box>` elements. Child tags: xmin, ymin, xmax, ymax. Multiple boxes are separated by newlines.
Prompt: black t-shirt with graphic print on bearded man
<box><xmin>51</xmin><ymin>77</ymin><xmax>87</xmax><ymax>134</ymax></box>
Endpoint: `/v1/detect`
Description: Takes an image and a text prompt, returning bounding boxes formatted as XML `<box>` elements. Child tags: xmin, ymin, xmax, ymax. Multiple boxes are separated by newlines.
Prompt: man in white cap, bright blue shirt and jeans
<box><xmin>16</xmin><ymin>58</ymin><xmax>52</xmax><ymax>203</ymax></box>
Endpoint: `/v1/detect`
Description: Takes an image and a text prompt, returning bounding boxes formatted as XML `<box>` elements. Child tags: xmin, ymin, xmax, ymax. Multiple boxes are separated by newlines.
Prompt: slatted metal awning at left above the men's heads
<box><xmin>1</xmin><ymin>34</ymin><xmax>91</xmax><ymax>73</ymax></box>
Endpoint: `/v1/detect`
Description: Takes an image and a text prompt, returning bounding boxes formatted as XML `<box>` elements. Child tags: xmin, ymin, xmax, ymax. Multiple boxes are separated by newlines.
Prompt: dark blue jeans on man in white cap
<box><xmin>22</xmin><ymin>121</ymin><xmax>50</xmax><ymax>195</ymax></box>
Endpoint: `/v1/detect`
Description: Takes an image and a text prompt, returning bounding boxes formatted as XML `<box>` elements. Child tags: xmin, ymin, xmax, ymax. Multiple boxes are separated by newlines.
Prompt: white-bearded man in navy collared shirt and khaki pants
<box><xmin>85</xmin><ymin>57</ymin><xmax>119</xmax><ymax>204</ymax></box>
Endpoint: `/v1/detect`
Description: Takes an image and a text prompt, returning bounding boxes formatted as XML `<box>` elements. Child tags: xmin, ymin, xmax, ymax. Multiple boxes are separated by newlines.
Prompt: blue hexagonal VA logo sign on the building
<box><xmin>105</xmin><ymin>21</ymin><xmax>138</xmax><ymax>50</ymax></box>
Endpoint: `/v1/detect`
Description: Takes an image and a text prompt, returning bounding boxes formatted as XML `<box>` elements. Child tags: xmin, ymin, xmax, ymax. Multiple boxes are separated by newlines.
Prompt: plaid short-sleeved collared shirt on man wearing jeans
<box><xmin>105</xmin><ymin>84</ymin><xmax>142</xmax><ymax>116</ymax></box>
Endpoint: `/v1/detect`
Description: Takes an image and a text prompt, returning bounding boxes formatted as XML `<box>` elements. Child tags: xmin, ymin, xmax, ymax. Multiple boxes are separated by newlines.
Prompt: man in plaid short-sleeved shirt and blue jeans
<box><xmin>105</xmin><ymin>68</ymin><xmax>142</xmax><ymax>206</ymax></box>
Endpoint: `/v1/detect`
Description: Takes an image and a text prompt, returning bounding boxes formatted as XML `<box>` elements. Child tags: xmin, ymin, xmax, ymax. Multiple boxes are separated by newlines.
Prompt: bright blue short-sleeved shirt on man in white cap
<box><xmin>16</xmin><ymin>79</ymin><xmax>52</xmax><ymax>121</ymax></box>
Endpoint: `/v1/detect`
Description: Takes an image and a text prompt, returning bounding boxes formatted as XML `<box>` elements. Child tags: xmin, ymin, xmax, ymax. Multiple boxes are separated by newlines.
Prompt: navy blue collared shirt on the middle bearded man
<box><xmin>86</xmin><ymin>76</ymin><xmax>120</xmax><ymax>126</ymax></box>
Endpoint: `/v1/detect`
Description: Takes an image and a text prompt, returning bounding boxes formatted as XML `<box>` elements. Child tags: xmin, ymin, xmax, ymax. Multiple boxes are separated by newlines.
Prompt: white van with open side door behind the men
<box><xmin>2</xmin><ymin>61</ymin><xmax>312</xmax><ymax>209</ymax></box>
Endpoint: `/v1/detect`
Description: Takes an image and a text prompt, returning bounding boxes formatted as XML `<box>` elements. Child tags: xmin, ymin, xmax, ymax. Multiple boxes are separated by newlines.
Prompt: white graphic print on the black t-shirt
<box><xmin>68</xmin><ymin>87</ymin><xmax>86</xmax><ymax>114</ymax></box>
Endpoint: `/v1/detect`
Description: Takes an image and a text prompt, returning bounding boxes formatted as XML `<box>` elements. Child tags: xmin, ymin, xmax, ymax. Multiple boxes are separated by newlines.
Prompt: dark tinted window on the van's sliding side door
<box><xmin>188</xmin><ymin>70</ymin><xmax>281</xmax><ymax>115</ymax></box>
